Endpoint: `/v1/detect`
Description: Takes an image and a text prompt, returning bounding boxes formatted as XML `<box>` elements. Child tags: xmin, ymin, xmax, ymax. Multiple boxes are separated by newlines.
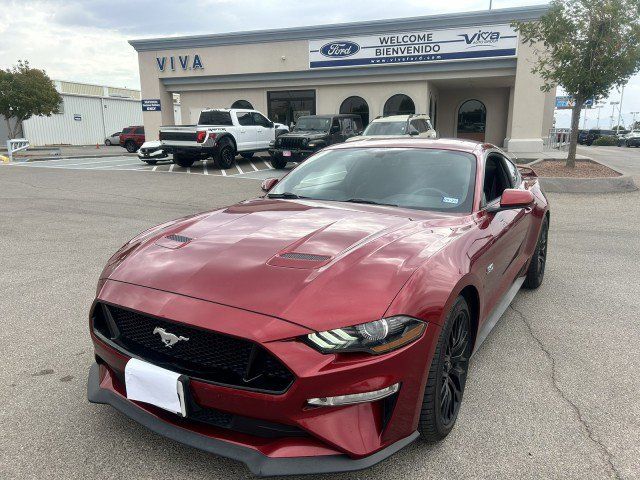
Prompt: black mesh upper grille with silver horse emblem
<box><xmin>93</xmin><ymin>304</ymin><xmax>294</xmax><ymax>393</ymax></box>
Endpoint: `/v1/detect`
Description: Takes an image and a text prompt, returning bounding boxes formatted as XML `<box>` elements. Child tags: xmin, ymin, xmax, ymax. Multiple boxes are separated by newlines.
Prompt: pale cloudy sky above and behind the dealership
<box><xmin>0</xmin><ymin>0</ymin><xmax>640</xmax><ymax>128</ymax></box>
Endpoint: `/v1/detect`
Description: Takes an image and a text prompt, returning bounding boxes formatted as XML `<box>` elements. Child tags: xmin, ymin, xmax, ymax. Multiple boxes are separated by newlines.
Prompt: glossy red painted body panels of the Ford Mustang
<box><xmin>92</xmin><ymin>139</ymin><xmax>548</xmax><ymax>472</ymax></box>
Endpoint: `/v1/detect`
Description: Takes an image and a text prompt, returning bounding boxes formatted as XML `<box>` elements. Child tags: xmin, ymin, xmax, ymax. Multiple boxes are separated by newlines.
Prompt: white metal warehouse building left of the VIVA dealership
<box><xmin>22</xmin><ymin>80</ymin><xmax>142</xmax><ymax>146</ymax></box>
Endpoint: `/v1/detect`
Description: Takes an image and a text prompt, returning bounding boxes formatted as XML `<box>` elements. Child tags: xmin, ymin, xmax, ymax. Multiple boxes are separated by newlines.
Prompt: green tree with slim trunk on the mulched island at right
<box><xmin>514</xmin><ymin>0</ymin><xmax>640</xmax><ymax>167</ymax></box>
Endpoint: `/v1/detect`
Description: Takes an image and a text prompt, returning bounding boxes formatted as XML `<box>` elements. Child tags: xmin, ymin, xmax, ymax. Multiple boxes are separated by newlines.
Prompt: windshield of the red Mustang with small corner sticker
<box><xmin>269</xmin><ymin>148</ymin><xmax>476</xmax><ymax>212</ymax></box>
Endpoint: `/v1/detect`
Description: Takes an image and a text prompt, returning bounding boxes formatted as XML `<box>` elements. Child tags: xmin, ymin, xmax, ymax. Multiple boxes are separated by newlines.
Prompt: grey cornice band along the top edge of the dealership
<box><xmin>129</xmin><ymin>5</ymin><xmax>549</xmax><ymax>52</ymax></box>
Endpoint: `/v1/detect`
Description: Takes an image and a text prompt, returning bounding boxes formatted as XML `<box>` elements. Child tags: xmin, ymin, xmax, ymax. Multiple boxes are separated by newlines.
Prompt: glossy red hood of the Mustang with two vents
<box><xmin>105</xmin><ymin>199</ymin><xmax>459</xmax><ymax>330</ymax></box>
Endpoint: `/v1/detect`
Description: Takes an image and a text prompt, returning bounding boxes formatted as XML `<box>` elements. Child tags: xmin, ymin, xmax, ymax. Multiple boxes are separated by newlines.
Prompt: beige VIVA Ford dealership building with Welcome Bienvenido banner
<box><xmin>130</xmin><ymin>6</ymin><xmax>555</xmax><ymax>153</ymax></box>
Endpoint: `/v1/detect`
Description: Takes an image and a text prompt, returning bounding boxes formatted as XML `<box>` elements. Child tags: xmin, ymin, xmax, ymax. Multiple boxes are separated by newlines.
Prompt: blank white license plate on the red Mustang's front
<box><xmin>124</xmin><ymin>358</ymin><xmax>187</xmax><ymax>417</ymax></box>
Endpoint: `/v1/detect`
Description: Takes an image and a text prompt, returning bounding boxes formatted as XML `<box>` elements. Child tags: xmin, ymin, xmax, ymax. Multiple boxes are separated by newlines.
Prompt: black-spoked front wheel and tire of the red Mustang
<box><xmin>418</xmin><ymin>296</ymin><xmax>471</xmax><ymax>442</ymax></box>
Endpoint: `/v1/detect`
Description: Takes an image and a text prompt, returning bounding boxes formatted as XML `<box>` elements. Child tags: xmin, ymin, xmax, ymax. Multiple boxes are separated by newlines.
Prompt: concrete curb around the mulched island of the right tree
<box><xmin>526</xmin><ymin>157</ymin><xmax>638</xmax><ymax>193</ymax></box>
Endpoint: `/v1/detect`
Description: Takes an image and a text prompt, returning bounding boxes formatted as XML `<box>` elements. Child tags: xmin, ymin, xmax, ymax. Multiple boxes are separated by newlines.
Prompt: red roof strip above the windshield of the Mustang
<box><xmin>327</xmin><ymin>137</ymin><xmax>490</xmax><ymax>153</ymax></box>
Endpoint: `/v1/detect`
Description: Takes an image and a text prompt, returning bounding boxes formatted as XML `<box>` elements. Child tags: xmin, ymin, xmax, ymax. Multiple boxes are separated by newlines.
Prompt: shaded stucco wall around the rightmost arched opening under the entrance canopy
<box><xmin>437</xmin><ymin>88</ymin><xmax>509</xmax><ymax>146</ymax></box>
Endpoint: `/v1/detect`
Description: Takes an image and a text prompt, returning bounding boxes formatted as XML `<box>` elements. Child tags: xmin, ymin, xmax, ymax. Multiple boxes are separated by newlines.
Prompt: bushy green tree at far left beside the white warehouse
<box><xmin>0</xmin><ymin>60</ymin><xmax>62</xmax><ymax>138</ymax></box>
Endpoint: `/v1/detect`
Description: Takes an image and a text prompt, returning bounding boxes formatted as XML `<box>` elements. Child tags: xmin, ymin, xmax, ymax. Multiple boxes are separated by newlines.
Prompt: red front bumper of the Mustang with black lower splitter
<box><xmin>89</xmin><ymin>280</ymin><xmax>439</xmax><ymax>475</ymax></box>
